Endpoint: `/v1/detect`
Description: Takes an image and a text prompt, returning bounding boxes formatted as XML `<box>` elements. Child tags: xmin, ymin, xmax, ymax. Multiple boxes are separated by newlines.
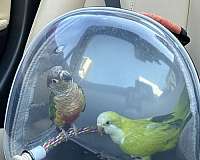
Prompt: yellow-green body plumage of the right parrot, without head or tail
<box><xmin>120</xmin><ymin>120</ymin><xmax>179</xmax><ymax>156</ymax></box>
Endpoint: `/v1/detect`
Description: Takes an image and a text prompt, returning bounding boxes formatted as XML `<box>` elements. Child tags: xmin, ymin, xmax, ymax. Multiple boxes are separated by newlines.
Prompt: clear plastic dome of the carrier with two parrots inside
<box><xmin>4</xmin><ymin>8</ymin><xmax>199</xmax><ymax>160</ymax></box>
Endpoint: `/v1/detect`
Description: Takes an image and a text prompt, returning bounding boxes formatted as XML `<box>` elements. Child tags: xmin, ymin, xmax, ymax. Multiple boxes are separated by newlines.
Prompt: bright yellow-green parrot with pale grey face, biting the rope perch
<box><xmin>97</xmin><ymin>88</ymin><xmax>191</xmax><ymax>160</ymax></box>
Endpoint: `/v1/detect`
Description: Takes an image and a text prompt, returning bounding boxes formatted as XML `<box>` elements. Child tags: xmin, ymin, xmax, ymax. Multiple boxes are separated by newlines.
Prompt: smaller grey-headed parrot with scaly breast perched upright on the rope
<box><xmin>47</xmin><ymin>66</ymin><xmax>86</xmax><ymax>128</ymax></box>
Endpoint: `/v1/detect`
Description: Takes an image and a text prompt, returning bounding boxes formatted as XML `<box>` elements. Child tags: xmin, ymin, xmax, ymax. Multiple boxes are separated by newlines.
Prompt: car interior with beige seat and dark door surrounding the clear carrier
<box><xmin>0</xmin><ymin>0</ymin><xmax>200</xmax><ymax>160</ymax></box>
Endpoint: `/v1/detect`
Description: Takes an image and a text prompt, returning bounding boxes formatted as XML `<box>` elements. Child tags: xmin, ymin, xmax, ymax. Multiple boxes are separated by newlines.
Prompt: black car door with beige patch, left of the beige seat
<box><xmin>0</xmin><ymin>0</ymin><xmax>40</xmax><ymax>128</ymax></box>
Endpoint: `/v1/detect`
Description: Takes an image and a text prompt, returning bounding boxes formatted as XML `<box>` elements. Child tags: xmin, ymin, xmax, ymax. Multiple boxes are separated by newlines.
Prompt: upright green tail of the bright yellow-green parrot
<box><xmin>173</xmin><ymin>86</ymin><xmax>192</xmax><ymax>128</ymax></box>
